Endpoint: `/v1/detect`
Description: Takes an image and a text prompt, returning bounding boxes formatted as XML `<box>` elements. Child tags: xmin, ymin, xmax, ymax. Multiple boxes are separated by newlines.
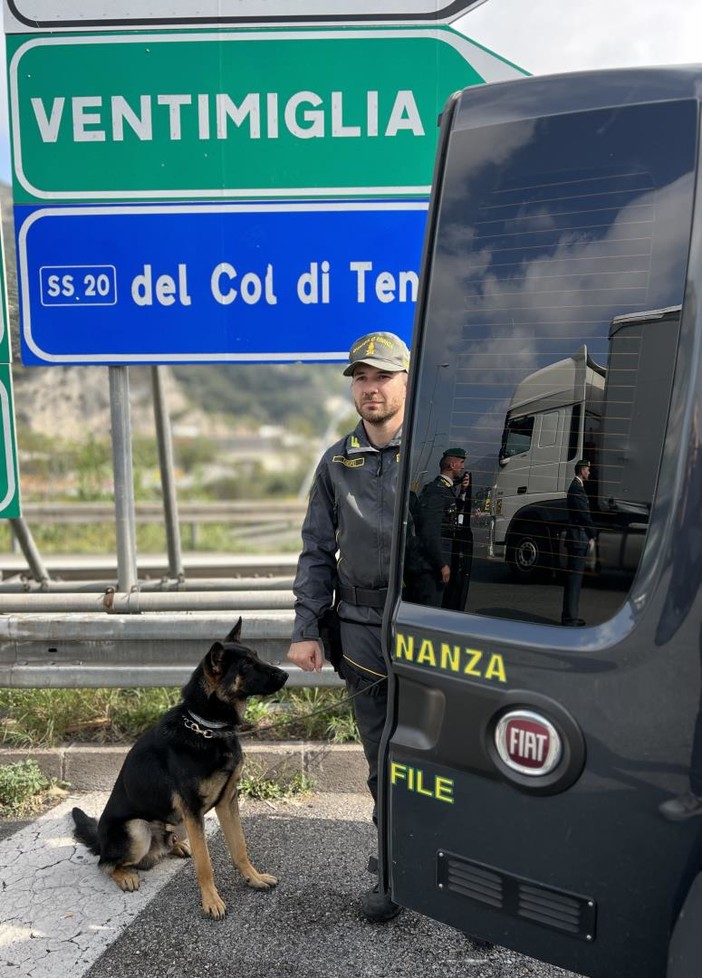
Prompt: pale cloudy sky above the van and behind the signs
<box><xmin>0</xmin><ymin>0</ymin><xmax>702</xmax><ymax>182</ymax></box>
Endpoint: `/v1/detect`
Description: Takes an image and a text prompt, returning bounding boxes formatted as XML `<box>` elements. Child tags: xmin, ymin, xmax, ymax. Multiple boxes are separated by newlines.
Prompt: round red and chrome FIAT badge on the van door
<box><xmin>495</xmin><ymin>710</ymin><xmax>563</xmax><ymax>778</ymax></box>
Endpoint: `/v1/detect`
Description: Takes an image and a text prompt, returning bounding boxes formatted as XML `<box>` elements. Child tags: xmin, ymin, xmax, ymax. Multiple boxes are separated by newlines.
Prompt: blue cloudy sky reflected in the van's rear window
<box><xmin>420</xmin><ymin>102</ymin><xmax>696</xmax><ymax>469</ymax></box>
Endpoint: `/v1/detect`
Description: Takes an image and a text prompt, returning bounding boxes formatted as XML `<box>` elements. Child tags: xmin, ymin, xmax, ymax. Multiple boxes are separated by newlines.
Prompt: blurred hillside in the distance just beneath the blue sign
<box><xmin>0</xmin><ymin>184</ymin><xmax>348</xmax><ymax>440</ymax></box>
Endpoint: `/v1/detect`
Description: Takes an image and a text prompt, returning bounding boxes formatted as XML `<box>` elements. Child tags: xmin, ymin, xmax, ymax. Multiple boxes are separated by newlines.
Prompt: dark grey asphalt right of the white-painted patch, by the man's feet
<box><xmin>77</xmin><ymin>793</ymin><xmax>584</xmax><ymax>978</ymax></box>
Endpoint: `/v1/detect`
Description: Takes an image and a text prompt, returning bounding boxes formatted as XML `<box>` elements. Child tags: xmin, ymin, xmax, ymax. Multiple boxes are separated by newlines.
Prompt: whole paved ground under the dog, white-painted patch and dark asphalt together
<box><xmin>0</xmin><ymin>793</ymin><xmax>584</xmax><ymax>978</ymax></box>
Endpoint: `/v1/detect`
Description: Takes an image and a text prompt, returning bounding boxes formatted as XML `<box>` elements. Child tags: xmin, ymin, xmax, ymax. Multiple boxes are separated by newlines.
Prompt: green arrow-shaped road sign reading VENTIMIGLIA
<box><xmin>7</xmin><ymin>26</ymin><xmax>524</xmax><ymax>204</ymax></box>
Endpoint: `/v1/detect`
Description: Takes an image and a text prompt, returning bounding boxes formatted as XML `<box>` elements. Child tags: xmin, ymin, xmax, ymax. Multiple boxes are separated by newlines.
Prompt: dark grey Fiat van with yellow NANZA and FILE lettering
<box><xmin>381</xmin><ymin>67</ymin><xmax>702</xmax><ymax>978</ymax></box>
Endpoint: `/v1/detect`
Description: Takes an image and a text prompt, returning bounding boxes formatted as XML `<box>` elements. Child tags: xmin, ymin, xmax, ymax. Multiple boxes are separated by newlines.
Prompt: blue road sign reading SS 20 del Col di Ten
<box><xmin>15</xmin><ymin>201</ymin><xmax>427</xmax><ymax>365</ymax></box>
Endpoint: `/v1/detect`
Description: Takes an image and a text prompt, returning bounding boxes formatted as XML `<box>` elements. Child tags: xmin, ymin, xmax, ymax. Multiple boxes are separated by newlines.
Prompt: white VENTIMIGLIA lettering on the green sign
<box><xmin>30</xmin><ymin>89</ymin><xmax>425</xmax><ymax>143</ymax></box>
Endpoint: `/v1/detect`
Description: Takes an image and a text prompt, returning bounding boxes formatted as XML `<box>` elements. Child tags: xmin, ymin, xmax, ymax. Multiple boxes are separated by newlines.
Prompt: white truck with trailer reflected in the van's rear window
<box><xmin>491</xmin><ymin>306</ymin><xmax>681</xmax><ymax>580</ymax></box>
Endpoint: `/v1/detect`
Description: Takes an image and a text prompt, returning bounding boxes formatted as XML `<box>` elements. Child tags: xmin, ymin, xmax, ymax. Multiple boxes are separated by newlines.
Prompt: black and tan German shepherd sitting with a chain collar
<box><xmin>73</xmin><ymin>618</ymin><xmax>288</xmax><ymax>920</ymax></box>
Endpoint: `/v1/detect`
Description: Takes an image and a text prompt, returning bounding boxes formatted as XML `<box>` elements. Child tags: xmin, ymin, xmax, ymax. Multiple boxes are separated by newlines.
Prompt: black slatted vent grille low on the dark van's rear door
<box><xmin>437</xmin><ymin>851</ymin><xmax>597</xmax><ymax>941</ymax></box>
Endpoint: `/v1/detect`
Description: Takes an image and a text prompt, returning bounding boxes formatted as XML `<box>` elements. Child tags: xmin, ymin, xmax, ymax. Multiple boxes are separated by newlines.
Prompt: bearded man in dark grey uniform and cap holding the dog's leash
<box><xmin>288</xmin><ymin>332</ymin><xmax>409</xmax><ymax>922</ymax></box>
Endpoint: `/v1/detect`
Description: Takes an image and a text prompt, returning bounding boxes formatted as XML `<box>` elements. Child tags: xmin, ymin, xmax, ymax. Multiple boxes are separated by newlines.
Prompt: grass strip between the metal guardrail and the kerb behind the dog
<box><xmin>0</xmin><ymin>687</ymin><xmax>358</xmax><ymax>748</ymax></box>
